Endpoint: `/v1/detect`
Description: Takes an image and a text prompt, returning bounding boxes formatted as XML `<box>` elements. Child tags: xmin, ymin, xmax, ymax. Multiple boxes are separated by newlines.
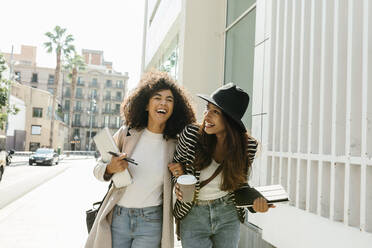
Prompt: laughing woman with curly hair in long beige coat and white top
<box><xmin>85</xmin><ymin>71</ymin><xmax>195</xmax><ymax>248</ymax></box>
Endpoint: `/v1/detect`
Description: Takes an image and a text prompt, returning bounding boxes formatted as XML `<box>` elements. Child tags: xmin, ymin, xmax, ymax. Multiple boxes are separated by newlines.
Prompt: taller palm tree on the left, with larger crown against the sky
<box><xmin>44</xmin><ymin>26</ymin><xmax>75</xmax><ymax>148</ymax></box>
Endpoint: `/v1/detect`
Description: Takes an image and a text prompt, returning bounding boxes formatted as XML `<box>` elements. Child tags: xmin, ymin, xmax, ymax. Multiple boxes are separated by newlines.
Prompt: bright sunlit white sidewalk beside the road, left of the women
<box><xmin>0</xmin><ymin>159</ymin><xmax>181</xmax><ymax>248</ymax></box>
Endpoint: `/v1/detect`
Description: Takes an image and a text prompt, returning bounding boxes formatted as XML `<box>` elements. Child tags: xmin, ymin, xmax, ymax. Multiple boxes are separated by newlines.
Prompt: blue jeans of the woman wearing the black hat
<box><xmin>180</xmin><ymin>196</ymin><xmax>240</xmax><ymax>248</ymax></box>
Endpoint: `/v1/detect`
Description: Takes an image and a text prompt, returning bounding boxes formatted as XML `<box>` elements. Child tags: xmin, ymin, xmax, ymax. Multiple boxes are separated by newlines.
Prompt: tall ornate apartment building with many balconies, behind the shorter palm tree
<box><xmin>62</xmin><ymin>49</ymin><xmax>129</xmax><ymax>150</ymax></box>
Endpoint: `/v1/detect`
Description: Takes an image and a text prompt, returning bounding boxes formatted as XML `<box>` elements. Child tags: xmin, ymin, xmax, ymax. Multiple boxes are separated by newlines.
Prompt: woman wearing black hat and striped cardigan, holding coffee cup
<box><xmin>168</xmin><ymin>83</ymin><xmax>274</xmax><ymax>248</ymax></box>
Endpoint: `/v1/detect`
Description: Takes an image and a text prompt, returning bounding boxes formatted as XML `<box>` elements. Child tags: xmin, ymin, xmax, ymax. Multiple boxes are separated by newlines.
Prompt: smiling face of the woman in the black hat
<box><xmin>204</xmin><ymin>103</ymin><xmax>225</xmax><ymax>135</ymax></box>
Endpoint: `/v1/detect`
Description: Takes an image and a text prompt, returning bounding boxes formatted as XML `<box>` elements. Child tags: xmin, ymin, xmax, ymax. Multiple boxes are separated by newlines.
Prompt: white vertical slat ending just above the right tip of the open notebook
<box><xmin>287</xmin><ymin>0</ymin><xmax>297</xmax><ymax>193</ymax></box>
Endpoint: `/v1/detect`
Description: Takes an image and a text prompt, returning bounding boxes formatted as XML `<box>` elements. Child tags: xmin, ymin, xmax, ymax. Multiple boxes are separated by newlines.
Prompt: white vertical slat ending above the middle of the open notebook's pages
<box><xmin>271</xmin><ymin>1</ymin><xmax>281</xmax><ymax>184</ymax></box>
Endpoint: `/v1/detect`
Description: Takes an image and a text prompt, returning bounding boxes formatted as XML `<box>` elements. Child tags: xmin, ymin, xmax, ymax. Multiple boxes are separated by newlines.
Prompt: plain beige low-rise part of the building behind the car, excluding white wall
<box><xmin>9</xmin><ymin>83</ymin><xmax>68</xmax><ymax>151</ymax></box>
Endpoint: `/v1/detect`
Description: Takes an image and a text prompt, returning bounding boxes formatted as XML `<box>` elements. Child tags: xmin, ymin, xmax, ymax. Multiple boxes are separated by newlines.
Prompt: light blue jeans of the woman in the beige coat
<box><xmin>111</xmin><ymin>205</ymin><xmax>163</xmax><ymax>248</ymax></box>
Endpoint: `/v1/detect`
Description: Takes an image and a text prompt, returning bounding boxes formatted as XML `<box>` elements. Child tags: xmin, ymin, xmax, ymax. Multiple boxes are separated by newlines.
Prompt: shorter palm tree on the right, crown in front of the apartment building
<box><xmin>64</xmin><ymin>51</ymin><xmax>86</xmax><ymax>148</ymax></box>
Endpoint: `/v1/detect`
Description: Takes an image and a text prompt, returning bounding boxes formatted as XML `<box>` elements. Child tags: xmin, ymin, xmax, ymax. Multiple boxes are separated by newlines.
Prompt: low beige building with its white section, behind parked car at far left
<box><xmin>7</xmin><ymin>82</ymin><xmax>68</xmax><ymax>151</ymax></box>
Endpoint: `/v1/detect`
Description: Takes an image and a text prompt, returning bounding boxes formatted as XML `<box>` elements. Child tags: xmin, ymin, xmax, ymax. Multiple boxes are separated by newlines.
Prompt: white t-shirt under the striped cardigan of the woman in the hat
<box><xmin>198</xmin><ymin>160</ymin><xmax>229</xmax><ymax>200</ymax></box>
